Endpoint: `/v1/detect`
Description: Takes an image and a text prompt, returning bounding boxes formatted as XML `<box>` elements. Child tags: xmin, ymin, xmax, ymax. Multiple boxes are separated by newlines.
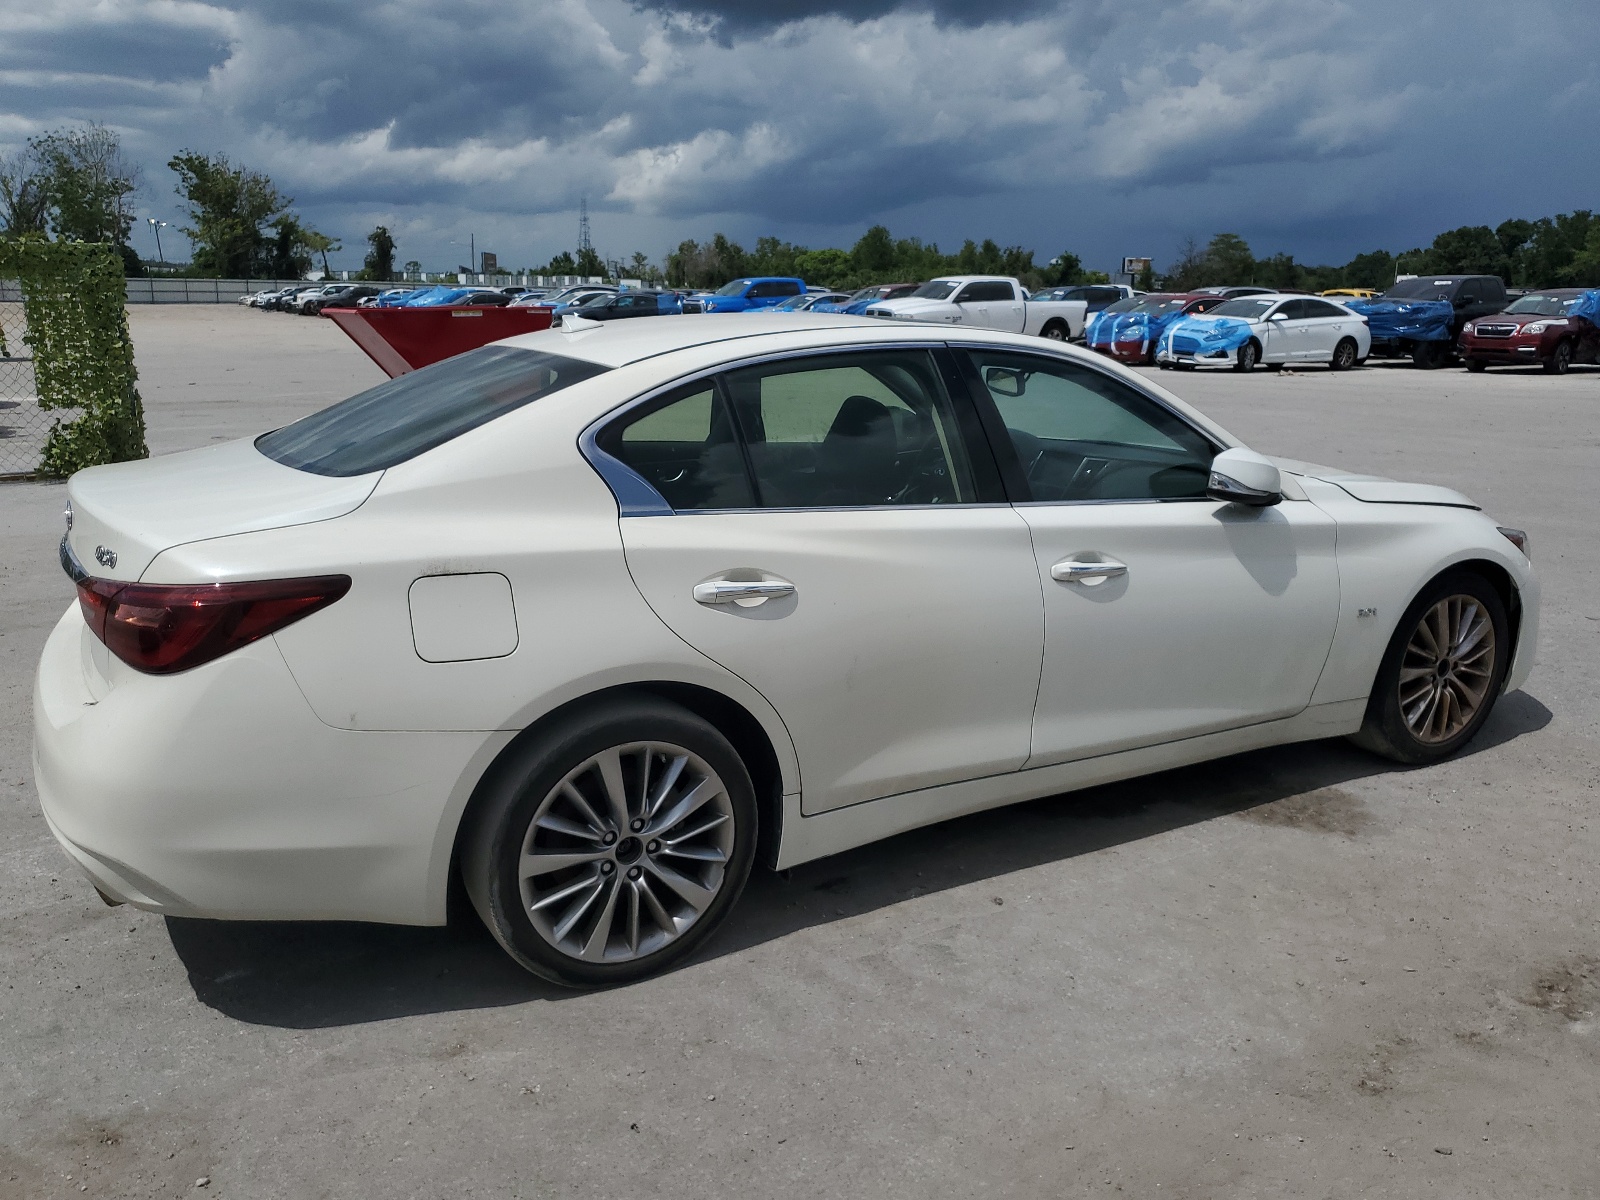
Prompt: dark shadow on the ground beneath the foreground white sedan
<box><xmin>166</xmin><ymin>691</ymin><xmax>1552</xmax><ymax>1029</ymax></box>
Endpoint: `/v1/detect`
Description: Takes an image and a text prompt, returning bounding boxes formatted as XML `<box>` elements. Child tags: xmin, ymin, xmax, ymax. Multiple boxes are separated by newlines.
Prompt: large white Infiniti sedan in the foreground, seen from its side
<box><xmin>34</xmin><ymin>314</ymin><xmax>1539</xmax><ymax>986</ymax></box>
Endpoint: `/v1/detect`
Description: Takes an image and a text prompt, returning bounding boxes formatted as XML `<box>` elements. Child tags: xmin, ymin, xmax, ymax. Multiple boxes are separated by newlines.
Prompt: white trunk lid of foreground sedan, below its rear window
<box><xmin>67</xmin><ymin>438</ymin><xmax>382</xmax><ymax>582</ymax></box>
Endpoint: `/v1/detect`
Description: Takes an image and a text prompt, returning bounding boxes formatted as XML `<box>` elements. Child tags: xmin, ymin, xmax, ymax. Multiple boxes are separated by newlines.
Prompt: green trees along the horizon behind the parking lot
<box><xmin>0</xmin><ymin>123</ymin><xmax>1600</xmax><ymax>291</ymax></box>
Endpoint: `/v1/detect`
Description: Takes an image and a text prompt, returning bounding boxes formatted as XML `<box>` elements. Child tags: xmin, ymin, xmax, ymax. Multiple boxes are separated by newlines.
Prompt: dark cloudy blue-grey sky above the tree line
<box><xmin>0</xmin><ymin>0</ymin><xmax>1600</xmax><ymax>269</ymax></box>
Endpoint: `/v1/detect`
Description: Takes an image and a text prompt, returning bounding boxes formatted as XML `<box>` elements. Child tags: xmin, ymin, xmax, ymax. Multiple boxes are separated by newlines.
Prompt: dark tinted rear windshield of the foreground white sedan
<box><xmin>256</xmin><ymin>346</ymin><xmax>611</xmax><ymax>477</ymax></box>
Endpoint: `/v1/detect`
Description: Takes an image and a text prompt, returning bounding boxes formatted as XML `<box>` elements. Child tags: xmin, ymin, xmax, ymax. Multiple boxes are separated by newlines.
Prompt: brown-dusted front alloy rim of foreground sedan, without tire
<box><xmin>1400</xmin><ymin>595</ymin><xmax>1498</xmax><ymax>746</ymax></box>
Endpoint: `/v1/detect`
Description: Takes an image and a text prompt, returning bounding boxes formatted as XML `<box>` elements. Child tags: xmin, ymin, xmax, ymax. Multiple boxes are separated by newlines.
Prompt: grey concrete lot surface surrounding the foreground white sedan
<box><xmin>0</xmin><ymin>307</ymin><xmax>1600</xmax><ymax>1200</ymax></box>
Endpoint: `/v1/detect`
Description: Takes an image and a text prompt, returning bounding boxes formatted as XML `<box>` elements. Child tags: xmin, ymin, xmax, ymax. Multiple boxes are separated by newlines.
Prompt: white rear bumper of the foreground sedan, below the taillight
<box><xmin>34</xmin><ymin>605</ymin><xmax>494</xmax><ymax>925</ymax></box>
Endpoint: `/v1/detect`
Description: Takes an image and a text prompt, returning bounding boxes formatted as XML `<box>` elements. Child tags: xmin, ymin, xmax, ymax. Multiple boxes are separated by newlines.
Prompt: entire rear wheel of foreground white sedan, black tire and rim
<box><xmin>461</xmin><ymin>696</ymin><xmax>757</xmax><ymax>987</ymax></box>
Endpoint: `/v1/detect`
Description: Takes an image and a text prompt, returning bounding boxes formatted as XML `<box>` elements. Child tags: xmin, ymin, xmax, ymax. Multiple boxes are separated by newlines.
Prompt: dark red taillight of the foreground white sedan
<box><xmin>78</xmin><ymin>574</ymin><xmax>350</xmax><ymax>675</ymax></box>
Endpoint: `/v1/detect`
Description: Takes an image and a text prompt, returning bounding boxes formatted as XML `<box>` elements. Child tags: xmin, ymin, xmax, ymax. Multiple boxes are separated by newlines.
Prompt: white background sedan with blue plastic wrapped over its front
<box><xmin>1155</xmin><ymin>294</ymin><xmax>1373</xmax><ymax>371</ymax></box>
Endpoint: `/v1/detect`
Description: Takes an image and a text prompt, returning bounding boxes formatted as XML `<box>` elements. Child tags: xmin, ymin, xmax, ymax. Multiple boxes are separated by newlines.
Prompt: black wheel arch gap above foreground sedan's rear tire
<box><xmin>444</xmin><ymin>680</ymin><xmax>786</xmax><ymax>920</ymax></box>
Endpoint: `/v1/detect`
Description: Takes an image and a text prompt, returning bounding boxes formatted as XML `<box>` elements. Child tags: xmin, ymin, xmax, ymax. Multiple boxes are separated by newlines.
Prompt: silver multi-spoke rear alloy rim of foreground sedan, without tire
<box><xmin>517</xmin><ymin>741</ymin><xmax>734</xmax><ymax>963</ymax></box>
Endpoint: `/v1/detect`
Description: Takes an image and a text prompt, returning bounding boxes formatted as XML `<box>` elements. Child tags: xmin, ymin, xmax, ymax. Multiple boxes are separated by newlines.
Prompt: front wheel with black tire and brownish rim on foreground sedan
<box><xmin>1352</xmin><ymin>571</ymin><xmax>1512</xmax><ymax>763</ymax></box>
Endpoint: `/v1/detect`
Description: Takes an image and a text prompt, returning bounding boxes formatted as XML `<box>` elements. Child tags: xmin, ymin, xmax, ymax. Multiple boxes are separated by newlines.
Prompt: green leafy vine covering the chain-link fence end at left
<box><xmin>0</xmin><ymin>238</ymin><xmax>150</xmax><ymax>477</ymax></box>
